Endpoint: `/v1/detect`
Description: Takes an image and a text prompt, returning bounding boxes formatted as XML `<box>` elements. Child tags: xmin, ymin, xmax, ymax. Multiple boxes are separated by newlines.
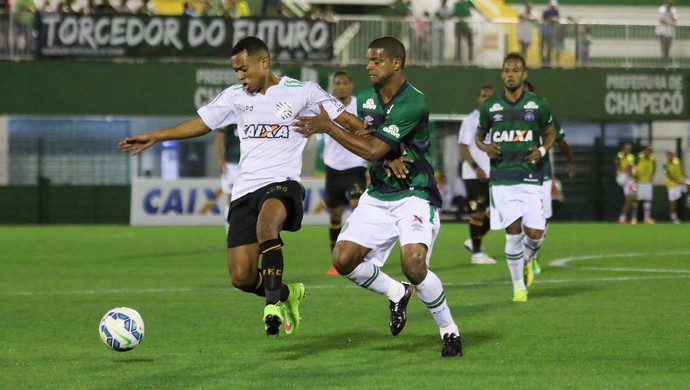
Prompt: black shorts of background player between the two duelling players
<box><xmin>324</xmin><ymin>166</ymin><xmax>367</xmax><ymax>209</ymax></box>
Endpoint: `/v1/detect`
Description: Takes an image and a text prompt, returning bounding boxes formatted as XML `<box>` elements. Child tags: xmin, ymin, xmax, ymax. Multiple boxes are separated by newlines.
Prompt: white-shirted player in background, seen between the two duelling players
<box><xmin>323</xmin><ymin>71</ymin><xmax>367</xmax><ymax>275</ymax></box>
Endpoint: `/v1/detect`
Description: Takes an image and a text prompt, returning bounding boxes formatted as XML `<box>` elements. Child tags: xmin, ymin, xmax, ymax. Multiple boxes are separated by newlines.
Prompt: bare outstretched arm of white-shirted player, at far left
<box><xmin>117</xmin><ymin>117</ymin><xmax>211</xmax><ymax>155</ymax></box>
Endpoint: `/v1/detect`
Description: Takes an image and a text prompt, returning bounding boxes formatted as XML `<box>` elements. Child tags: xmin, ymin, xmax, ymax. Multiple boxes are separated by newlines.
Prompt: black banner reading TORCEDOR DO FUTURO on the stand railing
<box><xmin>36</xmin><ymin>13</ymin><xmax>335</xmax><ymax>61</ymax></box>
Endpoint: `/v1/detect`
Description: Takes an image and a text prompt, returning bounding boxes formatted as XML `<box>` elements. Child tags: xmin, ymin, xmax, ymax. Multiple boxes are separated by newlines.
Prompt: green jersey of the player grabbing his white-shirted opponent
<box><xmin>357</xmin><ymin>82</ymin><xmax>442</xmax><ymax>207</ymax></box>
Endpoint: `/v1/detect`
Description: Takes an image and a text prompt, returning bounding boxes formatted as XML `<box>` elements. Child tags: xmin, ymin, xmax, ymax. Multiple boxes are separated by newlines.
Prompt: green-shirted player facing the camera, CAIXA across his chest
<box><xmin>475</xmin><ymin>52</ymin><xmax>556</xmax><ymax>302</ymax></box>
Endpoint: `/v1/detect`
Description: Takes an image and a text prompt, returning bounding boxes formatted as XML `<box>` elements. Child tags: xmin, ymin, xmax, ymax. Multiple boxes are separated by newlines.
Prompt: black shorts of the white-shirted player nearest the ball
<box><xmin>228</xmin><ymin>180</ymin><xmax>304</xmax><ymax>248</ymax></box>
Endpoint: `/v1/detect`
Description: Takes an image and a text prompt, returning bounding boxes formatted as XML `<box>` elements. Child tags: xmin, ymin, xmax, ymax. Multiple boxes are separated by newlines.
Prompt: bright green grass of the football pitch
<box><xmin>0</xmin><ymin>223</ymin><xmax>690</xmax><ymax>389</ymax></box>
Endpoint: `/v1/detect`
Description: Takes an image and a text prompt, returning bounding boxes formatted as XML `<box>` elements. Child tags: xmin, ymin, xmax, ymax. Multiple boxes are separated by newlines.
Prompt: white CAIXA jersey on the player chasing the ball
<box><xmin>197</xmin><ymin>77</ymin><xmax>345</xmax><ymax>200</ymax></box>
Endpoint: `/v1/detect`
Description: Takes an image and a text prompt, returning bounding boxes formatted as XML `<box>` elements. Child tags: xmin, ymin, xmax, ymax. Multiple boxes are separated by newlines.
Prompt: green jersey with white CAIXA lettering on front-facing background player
<box><xmin>477</xmin><ymin>92</ymin><xmax>553</xmax><ymax>185</ymax></box>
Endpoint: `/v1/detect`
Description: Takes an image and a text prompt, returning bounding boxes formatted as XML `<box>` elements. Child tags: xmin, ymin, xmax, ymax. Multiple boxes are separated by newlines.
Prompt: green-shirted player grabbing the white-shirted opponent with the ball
<box><xmin>295</xmin><ymin>36</ymin><xmax>462</xmax><ymax>357</ymax></box>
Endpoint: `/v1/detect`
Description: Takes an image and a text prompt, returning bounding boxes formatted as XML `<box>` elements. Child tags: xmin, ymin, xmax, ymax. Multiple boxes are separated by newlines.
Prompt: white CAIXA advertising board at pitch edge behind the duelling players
<box><xmin>130</xmin><ymin>178</ymin><xmax>328</xmax><ymax>226</ymax></box>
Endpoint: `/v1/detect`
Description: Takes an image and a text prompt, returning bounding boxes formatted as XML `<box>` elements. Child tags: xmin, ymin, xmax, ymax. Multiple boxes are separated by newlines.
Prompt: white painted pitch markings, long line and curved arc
<box><xmin>5</xmin><ymin>251</ymin><xmax>690</xmax><ymax>297</ymax></box>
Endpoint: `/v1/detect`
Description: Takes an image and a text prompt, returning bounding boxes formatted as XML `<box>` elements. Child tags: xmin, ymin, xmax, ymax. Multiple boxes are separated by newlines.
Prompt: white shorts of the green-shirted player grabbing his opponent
<box><xmin>338</xmin><ymin>191</ymin><xmax>441</xmax><ymax>267</ymax></box>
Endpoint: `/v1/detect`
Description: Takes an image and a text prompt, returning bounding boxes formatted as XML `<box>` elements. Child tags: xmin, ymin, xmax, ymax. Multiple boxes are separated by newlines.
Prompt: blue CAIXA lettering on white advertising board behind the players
<box><xmin>143</xmin><ymin>187</ymin><xmax>223</xmax><ymax>215</ymax></box>
